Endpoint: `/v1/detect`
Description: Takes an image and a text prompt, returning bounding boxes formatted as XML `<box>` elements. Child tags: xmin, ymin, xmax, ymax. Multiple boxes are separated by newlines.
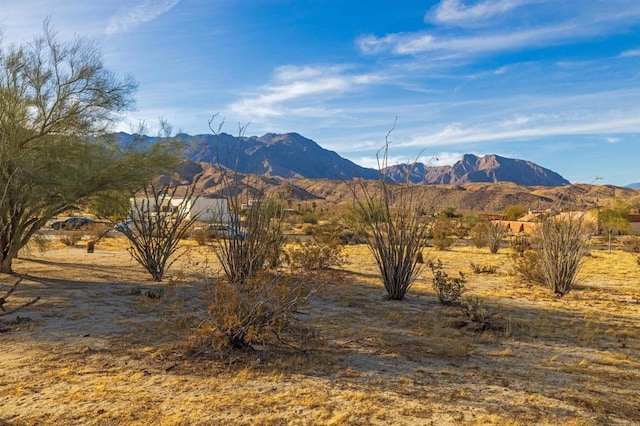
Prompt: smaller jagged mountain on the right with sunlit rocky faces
<box><xmin>387</xmin><ymin>154</ymin><xmax>570</xmax><ymax>186</ymax></box>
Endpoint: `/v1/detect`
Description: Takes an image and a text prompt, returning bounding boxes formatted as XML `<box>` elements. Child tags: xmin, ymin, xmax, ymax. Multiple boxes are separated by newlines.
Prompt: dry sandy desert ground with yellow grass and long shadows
<box><xmin>0</xmin><ymin>238</ymin><xmax>640</xmax><ymax>425</ymax></box>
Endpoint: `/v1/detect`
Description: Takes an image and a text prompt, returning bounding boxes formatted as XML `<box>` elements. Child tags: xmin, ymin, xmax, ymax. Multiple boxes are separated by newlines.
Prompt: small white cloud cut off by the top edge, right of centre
<box><xmin>425</xmin><ymin>0</ymin><xmax>540</xmax><ymax>26</ymax></box>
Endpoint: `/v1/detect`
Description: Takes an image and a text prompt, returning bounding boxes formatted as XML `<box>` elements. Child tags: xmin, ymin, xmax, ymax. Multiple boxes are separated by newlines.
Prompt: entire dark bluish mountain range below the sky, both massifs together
<box><xmin>117</xmin><ymin>133</ymin><xmax>569</xmax><ymax>186</ymax></box>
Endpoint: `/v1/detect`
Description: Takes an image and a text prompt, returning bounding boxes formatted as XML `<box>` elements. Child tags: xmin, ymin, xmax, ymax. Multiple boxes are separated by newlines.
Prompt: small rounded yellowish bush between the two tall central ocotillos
<box><xmin>285</xmin><ymin>241</ymin><xmax>346</xmax><ymax>271</ymax></box>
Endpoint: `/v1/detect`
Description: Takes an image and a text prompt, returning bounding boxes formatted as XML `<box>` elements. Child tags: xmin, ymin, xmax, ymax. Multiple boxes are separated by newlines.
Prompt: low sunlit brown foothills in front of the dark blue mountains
<box><xmin>172</xmin><ymin>161</ymin><xmax>640</xmax><ymax>212</ymax></box>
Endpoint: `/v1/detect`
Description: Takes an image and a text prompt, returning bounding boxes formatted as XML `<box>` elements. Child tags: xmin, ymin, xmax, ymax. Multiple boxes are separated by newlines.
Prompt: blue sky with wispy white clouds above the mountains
<box><xmin>0</xmin><ymin>0</ymin><xmax>640</xmax><ymax>185</ymax></box>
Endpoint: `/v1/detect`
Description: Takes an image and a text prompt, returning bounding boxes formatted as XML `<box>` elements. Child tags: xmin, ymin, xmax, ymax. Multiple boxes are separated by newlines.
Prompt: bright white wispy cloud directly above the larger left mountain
<box><xmin>229</xmin><ymin>65</ymin><xmax>382</xmax><ymax>119</ymax></box>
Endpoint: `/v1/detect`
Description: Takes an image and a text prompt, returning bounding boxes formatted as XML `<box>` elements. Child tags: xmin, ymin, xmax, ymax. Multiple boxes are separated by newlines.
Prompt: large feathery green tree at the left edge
<box><xmin>0</xmin><ymin>22</ymin><xmax>177</xmax><ymax>273</ymax></box>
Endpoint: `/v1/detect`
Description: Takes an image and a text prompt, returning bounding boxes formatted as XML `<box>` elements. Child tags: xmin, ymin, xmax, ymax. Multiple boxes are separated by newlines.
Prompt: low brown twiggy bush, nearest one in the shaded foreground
<box><xmin>201</xmin><ymin>271</ymin><xmax>316</xmax><ymax>350</ymax></box>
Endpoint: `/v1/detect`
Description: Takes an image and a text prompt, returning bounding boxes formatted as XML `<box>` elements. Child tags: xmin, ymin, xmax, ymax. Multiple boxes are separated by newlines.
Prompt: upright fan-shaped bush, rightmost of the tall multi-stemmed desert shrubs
<box><xmin>536</xmin><ymin>214</ymin><xmax>589</xmax><ymax>296</ymax></box>
